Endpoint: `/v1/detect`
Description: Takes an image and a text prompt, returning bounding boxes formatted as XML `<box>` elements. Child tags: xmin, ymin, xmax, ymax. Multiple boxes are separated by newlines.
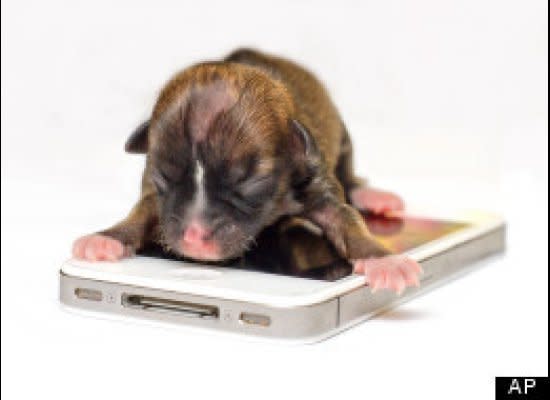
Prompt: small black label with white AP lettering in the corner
<box><xmin>495</xmin><ymin>376</ymin><xmax>548</xmax><ymax>400</ymax></box>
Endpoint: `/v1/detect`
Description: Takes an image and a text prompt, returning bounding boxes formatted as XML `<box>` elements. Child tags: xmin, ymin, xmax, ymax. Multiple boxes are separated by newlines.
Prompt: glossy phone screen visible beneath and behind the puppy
<box><xmin>141</xmin><ymin>215</ymin><xmax>468</xmax><ymax>281</ymax></box>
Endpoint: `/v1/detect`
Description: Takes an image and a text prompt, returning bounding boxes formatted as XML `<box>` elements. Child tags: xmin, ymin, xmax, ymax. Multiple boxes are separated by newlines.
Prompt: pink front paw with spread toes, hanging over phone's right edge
<box><xmin>353</xmin><ymin>255</ymin><xmax>423</xmax><ymax>295</ymax></box>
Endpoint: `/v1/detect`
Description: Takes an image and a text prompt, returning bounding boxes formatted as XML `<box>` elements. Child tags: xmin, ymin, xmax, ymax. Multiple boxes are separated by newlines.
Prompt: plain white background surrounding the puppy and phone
<box><xmin>1</xmin><ymin>0</ymin><xmax>548</xmax><ymax>400</ymax></box>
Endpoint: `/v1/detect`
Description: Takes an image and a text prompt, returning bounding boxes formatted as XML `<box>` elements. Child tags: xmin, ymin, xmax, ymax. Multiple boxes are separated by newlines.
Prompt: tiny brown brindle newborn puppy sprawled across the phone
<box><xmin>73</xmin><ymin>49</ymin><xmax>421</xmax><ymax>292</ymax></box>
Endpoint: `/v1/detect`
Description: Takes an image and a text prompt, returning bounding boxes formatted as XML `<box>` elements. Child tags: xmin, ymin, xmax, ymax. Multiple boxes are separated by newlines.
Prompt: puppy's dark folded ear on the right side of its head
<box><xmin>289</xmin><ymin>119</ymin><xmax>321</xmax><ymax>186</ymax></box>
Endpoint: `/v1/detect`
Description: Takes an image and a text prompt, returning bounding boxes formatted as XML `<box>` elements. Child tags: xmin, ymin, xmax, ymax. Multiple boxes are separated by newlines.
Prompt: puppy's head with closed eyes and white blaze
<box><xmin>127</xmin><ymin>64</ymin><xmax>317</xmax><ymax>261</ymax></box>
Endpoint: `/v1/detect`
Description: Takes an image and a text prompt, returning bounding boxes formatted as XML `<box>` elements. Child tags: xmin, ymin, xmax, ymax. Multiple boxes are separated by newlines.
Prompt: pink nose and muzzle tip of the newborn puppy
<box><xmin>180</xmin><ymin>220</ymin><xmax>220</xmax><ymax>261</ymax></box>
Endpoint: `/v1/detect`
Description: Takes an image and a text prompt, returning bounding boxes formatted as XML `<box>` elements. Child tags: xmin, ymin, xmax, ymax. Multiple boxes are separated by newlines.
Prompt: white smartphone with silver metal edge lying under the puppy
<box><xmin>60</xmin><ymin>209</ymin><xmax>506</xmax><ymax>342</ymax></box>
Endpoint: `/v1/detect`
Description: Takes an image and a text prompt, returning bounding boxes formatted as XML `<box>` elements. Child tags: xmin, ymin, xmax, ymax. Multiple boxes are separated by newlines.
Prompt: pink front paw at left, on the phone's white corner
<box><xmin>73</xmin><ymin>234</ymin><xmax>130</xmax><ymax>261</ymax></box>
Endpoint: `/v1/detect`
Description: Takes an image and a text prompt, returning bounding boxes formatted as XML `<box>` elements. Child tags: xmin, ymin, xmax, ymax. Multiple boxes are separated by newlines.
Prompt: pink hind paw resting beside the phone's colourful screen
<box><xmin>350</xmin><ymin>188</ymin><xmax>405</xmax><ymax>214</ymax></box>
